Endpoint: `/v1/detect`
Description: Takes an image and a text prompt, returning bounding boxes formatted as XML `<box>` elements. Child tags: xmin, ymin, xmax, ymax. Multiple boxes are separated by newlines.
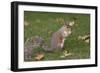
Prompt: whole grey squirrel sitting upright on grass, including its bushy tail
<box><xmin>24</xmin><ymin>21</ymin><xmax>74</xmax><ymax>60</ymax></box>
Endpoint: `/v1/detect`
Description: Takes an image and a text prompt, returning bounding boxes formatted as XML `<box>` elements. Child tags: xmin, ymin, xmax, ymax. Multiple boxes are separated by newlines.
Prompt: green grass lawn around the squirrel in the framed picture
<box><xmin>24</xmin><ymin>11</ymin><xmax>90</xmax><ymax>60</ymax></box>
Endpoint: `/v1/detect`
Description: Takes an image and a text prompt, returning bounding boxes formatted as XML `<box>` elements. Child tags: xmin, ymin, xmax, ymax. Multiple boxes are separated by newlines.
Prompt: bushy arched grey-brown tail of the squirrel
<box><xmin>24</xmin><ymin>36</ymin><xmax>44</xmax><ymax>61</ymax></box>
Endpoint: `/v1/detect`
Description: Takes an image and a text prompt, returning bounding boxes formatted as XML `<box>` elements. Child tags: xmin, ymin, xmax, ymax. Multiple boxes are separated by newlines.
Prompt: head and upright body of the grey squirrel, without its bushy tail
<box><xmin>42</xmin><ymin>21</ymin><xmax>74</xmax><ymax>52</ymax></box>
